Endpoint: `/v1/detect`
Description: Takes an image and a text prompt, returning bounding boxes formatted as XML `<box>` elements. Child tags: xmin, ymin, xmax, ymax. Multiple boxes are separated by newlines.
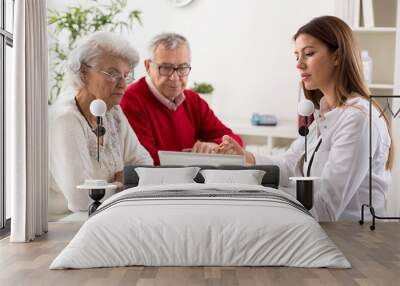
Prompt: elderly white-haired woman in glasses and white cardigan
<box><xmin>49</xmin><ymin>32</ymin><xmax>153</xmax><ymax>213</ymax></box>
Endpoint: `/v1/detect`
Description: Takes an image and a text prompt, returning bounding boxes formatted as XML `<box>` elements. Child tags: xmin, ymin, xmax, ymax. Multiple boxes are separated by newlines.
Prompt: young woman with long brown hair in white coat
<box><xmin>215</xmin><ymin>16</ymin><xmax>393</xmax><ymax>221</ymax></box>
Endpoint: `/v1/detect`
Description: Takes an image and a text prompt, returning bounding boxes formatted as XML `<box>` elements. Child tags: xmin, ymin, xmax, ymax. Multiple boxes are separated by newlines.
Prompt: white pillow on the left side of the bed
<box><xmin>135</xmin><ymin>167</ymin><xmax>200</xmax><ymax>186</ymax></box>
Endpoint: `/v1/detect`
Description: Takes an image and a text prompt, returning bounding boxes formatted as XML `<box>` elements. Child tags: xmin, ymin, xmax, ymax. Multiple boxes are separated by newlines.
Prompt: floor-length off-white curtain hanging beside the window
<box><xmin>6</xmin><ymin>0</ymin><xmax>48</xmax><ymax>242</ymax></box>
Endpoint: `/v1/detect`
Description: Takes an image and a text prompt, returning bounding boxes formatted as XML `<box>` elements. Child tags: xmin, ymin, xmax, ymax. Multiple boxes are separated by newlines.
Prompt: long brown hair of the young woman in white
<box><xmin>293</xmin><ymin>16</ymin><xmax>394</xmax><ymax>170</ymax></box>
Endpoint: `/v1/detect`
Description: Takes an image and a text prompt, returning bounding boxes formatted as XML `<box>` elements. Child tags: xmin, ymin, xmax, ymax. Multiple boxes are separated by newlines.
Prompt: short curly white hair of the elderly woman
<box><xmin>66</xmin><ymin>32</ymin><xmax>139</xmax><ymax>89</ymax></box>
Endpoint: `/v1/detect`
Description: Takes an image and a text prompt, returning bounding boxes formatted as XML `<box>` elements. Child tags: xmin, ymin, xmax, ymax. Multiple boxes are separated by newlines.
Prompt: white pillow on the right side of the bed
<box><xmin>200</xmin><ymin>170</ymin><xmax>265</xmax><ymax>185</ymax></box>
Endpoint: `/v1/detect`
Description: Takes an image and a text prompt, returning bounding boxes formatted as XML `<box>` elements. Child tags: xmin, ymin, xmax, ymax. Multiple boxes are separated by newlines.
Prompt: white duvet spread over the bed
<box><xmin>50</xmin><ymin>184</ymin><xmax>350</xmax><ymax>269</ymax></box>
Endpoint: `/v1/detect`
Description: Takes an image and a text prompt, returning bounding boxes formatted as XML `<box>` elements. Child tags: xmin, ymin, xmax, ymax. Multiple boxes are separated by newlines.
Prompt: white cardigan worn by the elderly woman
<box><xmin>49</xmin><ymin>99</ymin><xmax>153</xmax><ymax>212</ymax></box>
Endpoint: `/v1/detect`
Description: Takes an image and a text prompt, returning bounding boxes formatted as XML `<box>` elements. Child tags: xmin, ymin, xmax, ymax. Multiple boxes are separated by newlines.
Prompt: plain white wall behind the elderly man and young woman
<box><xmin>48</xmin><ymin>0</ymin><xmax>334</xmax><ymax>119</ymax></box>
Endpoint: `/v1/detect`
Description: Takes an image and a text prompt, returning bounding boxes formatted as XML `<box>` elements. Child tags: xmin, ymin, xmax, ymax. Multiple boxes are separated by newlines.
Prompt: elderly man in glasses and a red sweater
<box><xmin>121</xmin><ymin>33</ymin><xmax>242</xmax><ymax>165</ymax></box>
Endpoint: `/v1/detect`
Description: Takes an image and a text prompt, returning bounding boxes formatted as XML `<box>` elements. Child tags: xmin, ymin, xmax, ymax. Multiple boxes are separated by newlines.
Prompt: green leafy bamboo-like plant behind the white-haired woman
<box><xmin>48</xmin><ymin>0</ymin><xmax>142</xmax><ymax>104</ymax></box>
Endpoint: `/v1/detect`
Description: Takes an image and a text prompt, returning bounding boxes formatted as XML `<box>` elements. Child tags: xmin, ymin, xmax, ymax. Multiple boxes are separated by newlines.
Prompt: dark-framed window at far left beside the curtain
<box><xmin>0</xmin><ymin>0</ymin><xmax>14</xmax><ymax>233</ymax></box>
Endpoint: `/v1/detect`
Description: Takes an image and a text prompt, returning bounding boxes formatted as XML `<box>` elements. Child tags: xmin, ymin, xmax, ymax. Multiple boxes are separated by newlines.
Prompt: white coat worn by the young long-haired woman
<box><xmin>255</xmin><ymin>97</ymin><xmax>390</xmax><ymax>221</ymax></box>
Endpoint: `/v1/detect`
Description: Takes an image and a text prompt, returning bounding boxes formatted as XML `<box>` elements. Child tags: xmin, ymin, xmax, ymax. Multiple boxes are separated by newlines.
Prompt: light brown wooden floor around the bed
<box><xmin>0</xmin><ymin>222</ymin><xmax>400</xmax><ymax>286</ymax></box>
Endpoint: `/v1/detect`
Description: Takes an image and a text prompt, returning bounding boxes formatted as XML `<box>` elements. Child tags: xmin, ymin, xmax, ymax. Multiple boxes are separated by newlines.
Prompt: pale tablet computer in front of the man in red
<box><xmin>158</xmin><ymin>151</ymin><xmax>245</xmax><ymax>166</ymax></box>
